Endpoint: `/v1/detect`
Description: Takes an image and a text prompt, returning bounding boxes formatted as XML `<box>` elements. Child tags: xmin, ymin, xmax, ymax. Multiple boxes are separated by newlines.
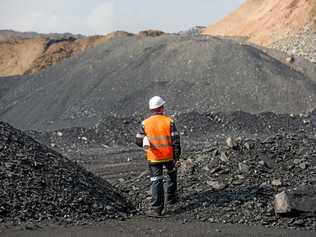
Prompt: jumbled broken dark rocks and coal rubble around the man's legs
<box><xmin>117</xmin><ymin>132</ymin><xmax>316</xmax><ymax>230</ymax></box>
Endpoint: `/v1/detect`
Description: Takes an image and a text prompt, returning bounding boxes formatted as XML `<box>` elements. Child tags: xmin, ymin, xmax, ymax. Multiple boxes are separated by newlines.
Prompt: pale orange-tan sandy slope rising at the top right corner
<box><xmin>203</xmin><ymin>0</ymin><xmax>316</xmax><ymax>60</ymax></box>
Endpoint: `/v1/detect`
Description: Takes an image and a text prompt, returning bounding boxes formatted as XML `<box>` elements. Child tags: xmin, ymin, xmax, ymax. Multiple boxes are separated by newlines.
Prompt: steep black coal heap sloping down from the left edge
<box><xmin>0</xmin><ymin>122</ymin><xmax>132</xmax><ymax>223</ymax></box>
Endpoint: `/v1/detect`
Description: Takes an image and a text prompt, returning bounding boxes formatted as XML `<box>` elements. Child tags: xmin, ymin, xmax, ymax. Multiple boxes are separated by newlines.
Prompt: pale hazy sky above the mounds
<box><xmin>0</xmin><ymin>0</ymin><xmax>244</xmax><ymax>35</ymax></box>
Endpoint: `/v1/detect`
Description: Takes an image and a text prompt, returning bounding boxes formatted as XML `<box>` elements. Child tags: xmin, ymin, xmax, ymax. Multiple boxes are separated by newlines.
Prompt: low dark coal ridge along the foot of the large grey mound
<box><xmin>27</xmin><ymin>111</ymin><xmax>316</xmax><ymax>155</ymax></box>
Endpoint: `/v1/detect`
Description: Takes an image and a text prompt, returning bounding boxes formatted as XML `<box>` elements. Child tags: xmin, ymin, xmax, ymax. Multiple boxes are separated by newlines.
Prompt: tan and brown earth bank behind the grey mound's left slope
<box><xmin>0</xmin><ymin>32</ymin><xmax>132</xmax><ymax>76</ymax></box>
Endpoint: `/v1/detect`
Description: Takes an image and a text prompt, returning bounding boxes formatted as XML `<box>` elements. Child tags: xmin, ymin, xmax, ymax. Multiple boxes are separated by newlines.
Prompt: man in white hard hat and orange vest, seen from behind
<box><xmin>136</xmin><ymin>96</ymin><xmax>181</xmax><ymax>217</ymax></box>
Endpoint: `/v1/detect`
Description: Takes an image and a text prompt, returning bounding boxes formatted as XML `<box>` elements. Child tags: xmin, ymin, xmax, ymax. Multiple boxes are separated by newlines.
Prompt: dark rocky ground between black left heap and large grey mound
<box><xmin>0</xmin><ymin>112</ymin><xmax>308</xmax><ymax>230</ymax></box>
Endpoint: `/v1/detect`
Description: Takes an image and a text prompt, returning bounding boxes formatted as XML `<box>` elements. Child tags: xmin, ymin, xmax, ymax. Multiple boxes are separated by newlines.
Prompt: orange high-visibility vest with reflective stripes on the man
<box><xmin>143</xmin><ymin>115</ymin><xmax>173</xmax><ymax>163</ymax></box>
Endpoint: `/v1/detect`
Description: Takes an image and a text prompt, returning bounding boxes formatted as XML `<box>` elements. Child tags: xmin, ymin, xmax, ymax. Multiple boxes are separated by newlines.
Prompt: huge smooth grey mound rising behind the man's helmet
<box><xmin>0</xmin><ymin>35</ymin><xmax>316</xmax><ymax>129</ymax></box>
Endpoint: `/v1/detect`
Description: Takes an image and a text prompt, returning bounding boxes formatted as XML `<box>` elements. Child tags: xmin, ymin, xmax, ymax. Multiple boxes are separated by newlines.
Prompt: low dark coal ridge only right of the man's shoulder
<box><xmin>175</xmin><ymin>111</ymin><xmax>316</xmax><ymax>139</ymax></box>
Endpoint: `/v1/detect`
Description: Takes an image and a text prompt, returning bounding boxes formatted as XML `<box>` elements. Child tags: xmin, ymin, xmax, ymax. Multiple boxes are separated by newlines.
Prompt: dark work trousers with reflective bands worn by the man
<box><xmin>149</xmin><ymin>161</ymin><xmax>177</xmax><ymax>211</ymax></box>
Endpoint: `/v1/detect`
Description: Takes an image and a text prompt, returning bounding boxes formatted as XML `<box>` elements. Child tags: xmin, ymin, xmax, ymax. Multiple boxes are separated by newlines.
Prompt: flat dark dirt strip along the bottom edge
<box><xmin>0</xmin><ymin>218</ymin><xmax>315</xmax><ymax>237</ymax></box>
